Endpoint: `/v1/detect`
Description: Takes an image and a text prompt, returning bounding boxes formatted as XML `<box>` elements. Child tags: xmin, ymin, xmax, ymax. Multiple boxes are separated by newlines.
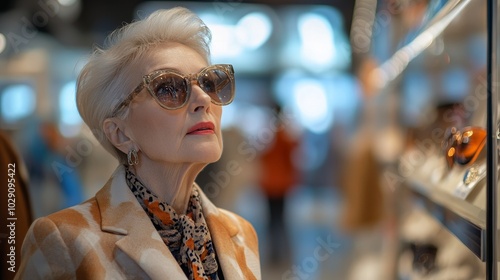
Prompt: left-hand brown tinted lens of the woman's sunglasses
<box><xmin>150</xmin><ymin>73</ymin><xmax>188</xmax><ymax>109</ymax></box>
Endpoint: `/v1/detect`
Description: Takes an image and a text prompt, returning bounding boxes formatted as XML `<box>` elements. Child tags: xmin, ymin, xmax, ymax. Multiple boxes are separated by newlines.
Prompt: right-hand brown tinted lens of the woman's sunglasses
<box><xmin>198</xmin><ymin>68</ymin><xmax>234</xmax><ymax>105</ymax></box>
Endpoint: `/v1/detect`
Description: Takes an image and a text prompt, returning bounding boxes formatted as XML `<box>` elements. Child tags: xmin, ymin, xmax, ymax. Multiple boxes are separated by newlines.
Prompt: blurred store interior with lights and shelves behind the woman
<box><xmin>0</xmin><ymin>0</ymin><xmax>498</xmax><ymax>280</ymax></box>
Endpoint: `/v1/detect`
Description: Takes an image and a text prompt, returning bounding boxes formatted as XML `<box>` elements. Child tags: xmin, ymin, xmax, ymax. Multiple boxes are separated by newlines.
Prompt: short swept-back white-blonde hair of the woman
<box><xmin>76</xmin><ymin>7</ymin><xmax>211</xmax><ymax>163</ymax></box>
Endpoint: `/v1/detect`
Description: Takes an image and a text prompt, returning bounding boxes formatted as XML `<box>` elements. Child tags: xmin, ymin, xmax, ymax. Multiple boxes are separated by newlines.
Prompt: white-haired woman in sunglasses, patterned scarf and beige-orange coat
<box><xmin>17</xmin><ymin>8</ymin><xmax>260</xmax><ymax>279</ymax></box>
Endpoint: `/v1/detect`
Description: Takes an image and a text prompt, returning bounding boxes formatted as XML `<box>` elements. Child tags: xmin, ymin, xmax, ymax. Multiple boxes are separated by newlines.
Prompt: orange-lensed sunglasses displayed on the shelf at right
<box><xmin>441</xmin><ymin>126</ymin><xmax>486</xmax><ymax>168</ymax></box>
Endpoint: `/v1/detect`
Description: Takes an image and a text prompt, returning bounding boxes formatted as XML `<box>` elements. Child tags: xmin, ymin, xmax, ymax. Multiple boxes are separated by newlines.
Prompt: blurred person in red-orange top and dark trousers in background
<box><xmin>258</xmin><ymin>105</ymin><xmax>299</xmax><ymax>262</ymax></box>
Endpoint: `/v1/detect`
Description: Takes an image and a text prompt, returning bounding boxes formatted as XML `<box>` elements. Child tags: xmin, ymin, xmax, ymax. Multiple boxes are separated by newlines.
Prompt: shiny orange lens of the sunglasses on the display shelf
<box><xmin>455</xmin><ymin>128</ymin><xmax>486</xmax><ymax>165</ymax></box>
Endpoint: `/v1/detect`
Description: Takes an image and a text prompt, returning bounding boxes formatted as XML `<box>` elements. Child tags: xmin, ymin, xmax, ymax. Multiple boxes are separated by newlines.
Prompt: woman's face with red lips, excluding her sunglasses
<box><xmin>125</xmin><ymin>43</ymin><xmax>222</xmax><ymax>164</ymax></box>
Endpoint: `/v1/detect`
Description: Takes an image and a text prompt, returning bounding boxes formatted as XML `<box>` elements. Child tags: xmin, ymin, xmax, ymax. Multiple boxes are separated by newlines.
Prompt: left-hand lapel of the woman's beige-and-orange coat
<box><xmin>96</xmin><ymin>166</ymin><xmax>187</xmax><ymax>280</ymax></box>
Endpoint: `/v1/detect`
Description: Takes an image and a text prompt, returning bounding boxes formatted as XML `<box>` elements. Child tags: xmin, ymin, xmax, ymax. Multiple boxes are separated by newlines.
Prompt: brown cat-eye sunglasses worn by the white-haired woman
<box><xmin>112</xmin><ymin>64</ymin><xmax>234</xmax><ymax>116</ymax></box>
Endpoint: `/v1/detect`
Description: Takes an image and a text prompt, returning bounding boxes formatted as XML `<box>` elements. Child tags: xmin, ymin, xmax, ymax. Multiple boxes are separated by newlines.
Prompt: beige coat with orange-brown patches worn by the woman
<box><xmin>16</xmin><ymin>167</ymin><xmax>261</xmax><ymax>280</ymax></box>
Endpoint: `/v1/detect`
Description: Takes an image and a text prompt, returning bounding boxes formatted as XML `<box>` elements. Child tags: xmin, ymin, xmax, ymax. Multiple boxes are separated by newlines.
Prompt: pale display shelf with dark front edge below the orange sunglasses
<box><xmin>405</xmin><ymin>155</ymin><xmax>500</xmax><ymax>261</ymax></box>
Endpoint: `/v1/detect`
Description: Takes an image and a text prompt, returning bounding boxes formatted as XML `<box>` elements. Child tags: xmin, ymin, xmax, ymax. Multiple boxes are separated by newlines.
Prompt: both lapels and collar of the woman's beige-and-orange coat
<box><xmin>96</xmin><ymin>165</ymin><xmax>243</xmax><ymax>279</ymax></box>
